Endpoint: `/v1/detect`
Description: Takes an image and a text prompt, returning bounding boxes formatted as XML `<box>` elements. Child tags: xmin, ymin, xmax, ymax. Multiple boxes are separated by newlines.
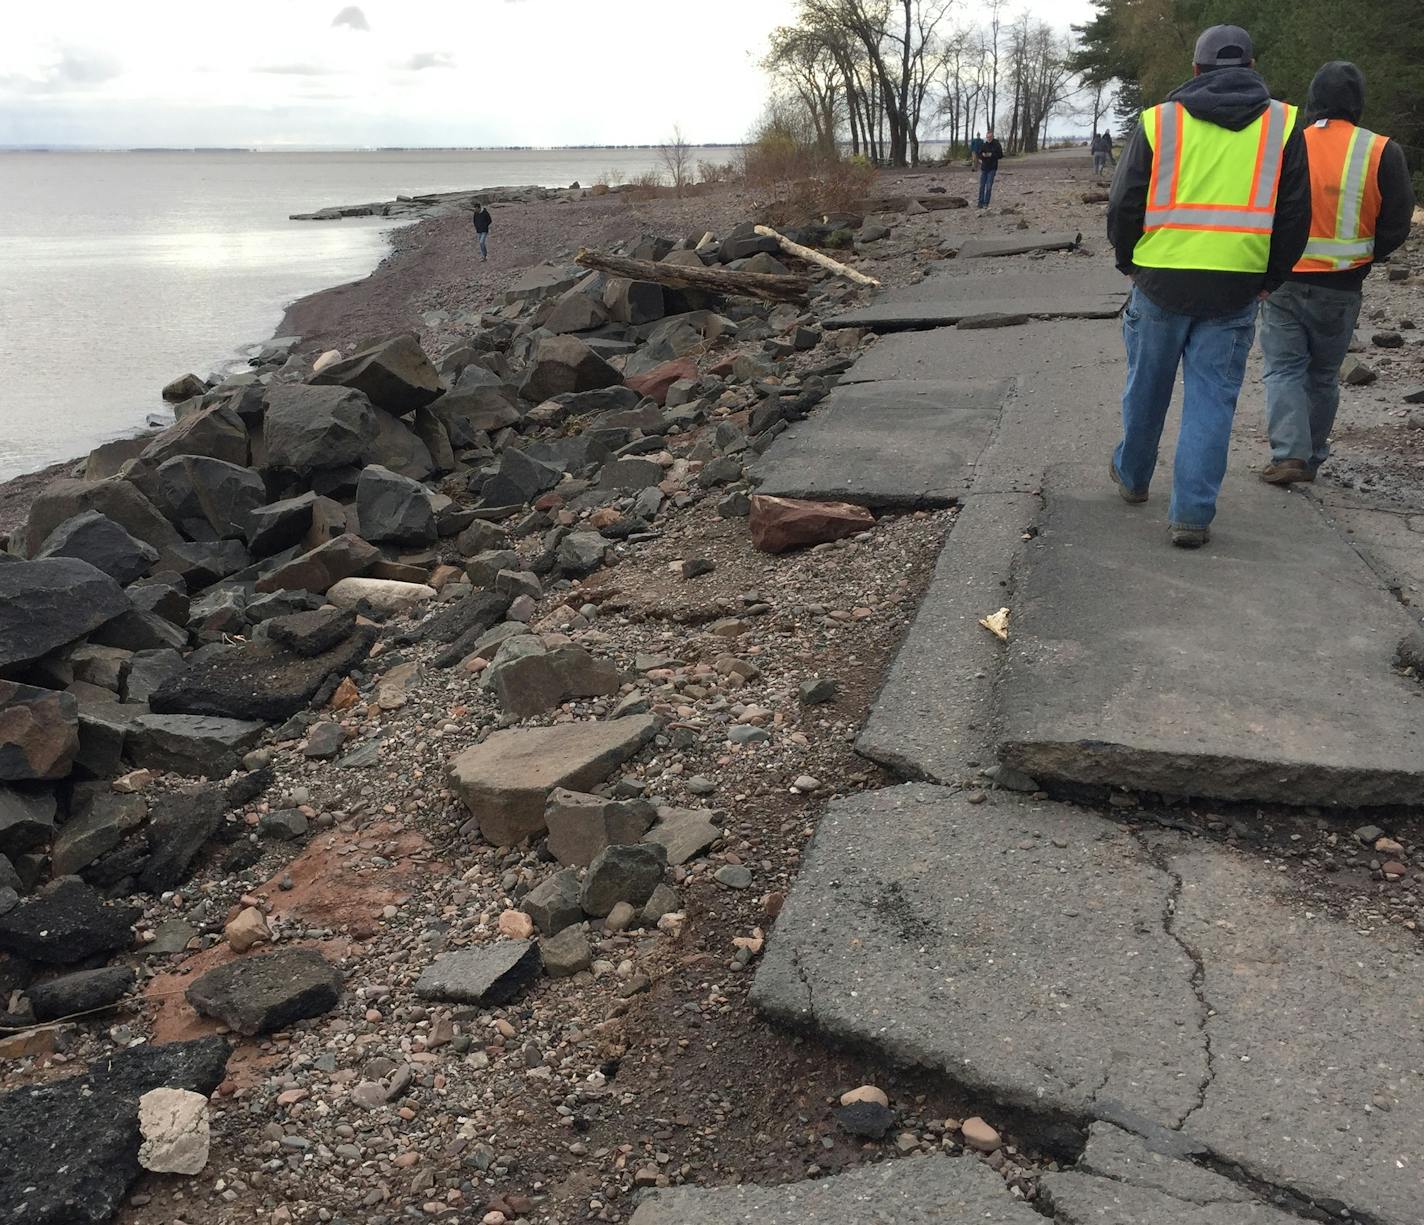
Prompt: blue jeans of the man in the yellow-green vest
<box><xmin>1112</xmin><ymin>288</ymin><xmax>1256</xmax><ymax>527</ymax></box>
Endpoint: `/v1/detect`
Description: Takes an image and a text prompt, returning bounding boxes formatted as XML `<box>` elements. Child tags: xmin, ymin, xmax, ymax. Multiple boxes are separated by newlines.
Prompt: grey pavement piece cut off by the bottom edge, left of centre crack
<box><xmin>631</xmin><ymin>1157</ymin><xmax>1044</xmax><ymax>1225</ymax></box>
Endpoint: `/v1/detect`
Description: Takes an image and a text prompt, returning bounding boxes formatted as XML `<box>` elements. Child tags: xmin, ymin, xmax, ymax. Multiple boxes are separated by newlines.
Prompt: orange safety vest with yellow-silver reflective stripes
<box><xmin>1294</xmin><ymin>120</ymin><xmax>1390</xmax><ymax>272</ymax></box>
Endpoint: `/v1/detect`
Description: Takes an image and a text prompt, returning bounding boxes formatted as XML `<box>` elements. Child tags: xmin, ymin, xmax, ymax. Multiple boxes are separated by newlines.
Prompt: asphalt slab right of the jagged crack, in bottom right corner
<box><xmin>1165</xmin><ymin>846</ymin><xmax>1424</xmax><ymax>1225</ymax></box>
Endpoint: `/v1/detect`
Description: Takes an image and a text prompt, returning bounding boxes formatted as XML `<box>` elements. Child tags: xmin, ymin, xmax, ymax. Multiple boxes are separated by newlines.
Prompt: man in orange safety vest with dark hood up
<box><xmin>1260</xmin><ymin>60</ymin><xmax>1414</xmax><ymax>484</ymax></box>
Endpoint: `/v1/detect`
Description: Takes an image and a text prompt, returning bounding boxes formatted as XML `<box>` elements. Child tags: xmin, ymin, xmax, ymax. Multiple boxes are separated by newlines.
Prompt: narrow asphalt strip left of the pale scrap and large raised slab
<box><xmin>856</xmin><ymin>493</ymin><xmax>1038</xmax><ymax>782</ymax></box>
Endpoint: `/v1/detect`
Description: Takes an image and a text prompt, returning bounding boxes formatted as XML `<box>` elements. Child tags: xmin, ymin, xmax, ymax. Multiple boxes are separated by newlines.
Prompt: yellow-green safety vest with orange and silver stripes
<box><xmin>1134</xmin><ymin>101</ymin><xmax>1296</xmax><ymax>272</ymax></box>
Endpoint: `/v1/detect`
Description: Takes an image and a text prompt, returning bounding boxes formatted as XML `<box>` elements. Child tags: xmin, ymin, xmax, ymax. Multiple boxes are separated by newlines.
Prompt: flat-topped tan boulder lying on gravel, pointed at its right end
<box><xmin>450</xmin><ymin>715</ymin><xmax>658</xmax><ymax>846</ymax></box>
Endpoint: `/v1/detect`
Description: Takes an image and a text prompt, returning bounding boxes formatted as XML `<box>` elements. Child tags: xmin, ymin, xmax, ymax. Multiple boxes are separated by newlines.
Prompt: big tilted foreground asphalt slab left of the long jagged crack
<box><xmin>752</xmin><ymin>783</ymin><xmax>1206</xmax><ymax>1122</ymax></box>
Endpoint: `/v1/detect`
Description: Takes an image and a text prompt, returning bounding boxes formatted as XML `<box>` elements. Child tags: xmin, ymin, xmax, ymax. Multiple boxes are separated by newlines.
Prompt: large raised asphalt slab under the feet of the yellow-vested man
<box><xmin>995</xmin><ymin>467</ymin><xmax>1424</xmax><ymax>808</ymax></box>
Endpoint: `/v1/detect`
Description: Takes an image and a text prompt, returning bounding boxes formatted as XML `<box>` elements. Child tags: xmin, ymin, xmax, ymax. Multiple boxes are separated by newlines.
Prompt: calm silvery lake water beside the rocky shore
<box><xmin>0</xmin><ymin>150</ymin><xmax>732</xmax><ymax>480</ymax></box>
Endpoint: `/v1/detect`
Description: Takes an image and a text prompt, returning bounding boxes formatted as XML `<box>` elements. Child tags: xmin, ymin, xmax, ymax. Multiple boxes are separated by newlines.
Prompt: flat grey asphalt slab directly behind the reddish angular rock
<box><xmin>750</xmin><ymin>379</ymin><xmax>1010</xmax><ymax>510</ymax></box>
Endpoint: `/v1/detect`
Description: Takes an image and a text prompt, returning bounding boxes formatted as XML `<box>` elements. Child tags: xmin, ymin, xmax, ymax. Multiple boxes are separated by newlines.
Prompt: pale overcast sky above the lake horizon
<box><xmin>0</xmin><ymin>0</ymin><xmax>1091</xmax><ymax>147</ymax></box>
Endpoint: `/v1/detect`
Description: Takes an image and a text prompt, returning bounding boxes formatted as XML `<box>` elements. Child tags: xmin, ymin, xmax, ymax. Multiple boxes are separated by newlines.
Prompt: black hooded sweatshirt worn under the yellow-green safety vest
<box><xmin>1108</xmin><ymin>68</ymin><xmax>1310</xmax><ymax>318</ymax></box>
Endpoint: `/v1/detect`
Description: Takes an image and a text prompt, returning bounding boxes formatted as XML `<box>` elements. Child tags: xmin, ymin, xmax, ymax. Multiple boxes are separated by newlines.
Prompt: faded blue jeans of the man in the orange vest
<box><xmin>1260</xmin><ymin>281</ymin><xmax>1360</xmax><ymax>469</ymax></box>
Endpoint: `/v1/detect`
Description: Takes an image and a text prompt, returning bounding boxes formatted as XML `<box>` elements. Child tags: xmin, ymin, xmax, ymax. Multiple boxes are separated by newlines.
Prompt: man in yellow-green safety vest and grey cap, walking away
<box><xmin>1108</xmin><ymin>26</ymin><xmax>1310</xmax><ymax>548</ymax></box>
